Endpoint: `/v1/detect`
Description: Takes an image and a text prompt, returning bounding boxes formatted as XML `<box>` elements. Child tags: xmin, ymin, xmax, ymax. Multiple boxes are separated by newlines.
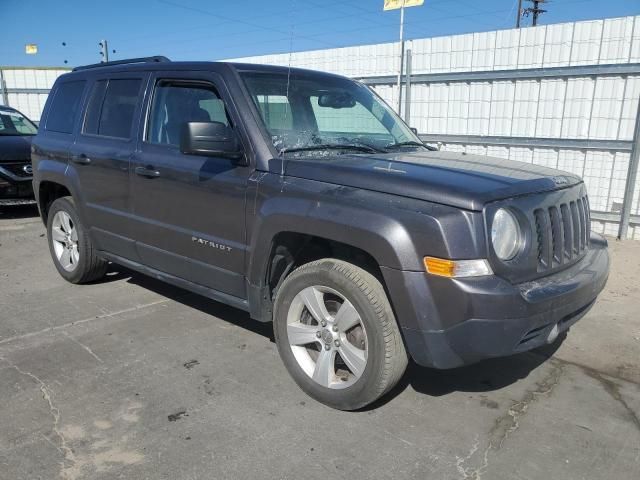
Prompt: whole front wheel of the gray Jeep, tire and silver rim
<box><xmin>274</xmin><ymin>259</ymin><xmax>407</xmax><ymax>410</ymax></box>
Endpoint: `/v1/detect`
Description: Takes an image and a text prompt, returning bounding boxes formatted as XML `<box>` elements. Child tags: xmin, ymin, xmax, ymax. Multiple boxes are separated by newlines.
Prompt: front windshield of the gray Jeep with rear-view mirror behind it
<box><xmin>242</xmin><ymin>72</ymin><xmax>425</xmax><ymax>154</ymax></box>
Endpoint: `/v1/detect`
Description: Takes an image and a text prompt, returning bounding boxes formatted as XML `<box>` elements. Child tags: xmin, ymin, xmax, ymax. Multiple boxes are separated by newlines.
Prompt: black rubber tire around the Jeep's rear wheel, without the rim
<box><xmin>47</xmin><ymin>197</ymin><xmax>109</xmax><ymax>283</ymax></box>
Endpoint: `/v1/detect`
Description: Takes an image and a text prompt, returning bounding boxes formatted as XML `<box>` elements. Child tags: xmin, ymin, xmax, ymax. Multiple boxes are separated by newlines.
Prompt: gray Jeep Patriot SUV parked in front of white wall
<box><xmin>32</xmin><ymin>57</ymin><xmax>609</xmax><ymax>410</ymax></box>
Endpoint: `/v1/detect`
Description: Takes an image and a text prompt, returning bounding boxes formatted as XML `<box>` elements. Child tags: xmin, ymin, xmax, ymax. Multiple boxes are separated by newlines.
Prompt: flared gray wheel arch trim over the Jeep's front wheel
<box><xmin>242</xmin><ymin>206</ymin><xmax>415</xmax><ymax>321</ymax></box>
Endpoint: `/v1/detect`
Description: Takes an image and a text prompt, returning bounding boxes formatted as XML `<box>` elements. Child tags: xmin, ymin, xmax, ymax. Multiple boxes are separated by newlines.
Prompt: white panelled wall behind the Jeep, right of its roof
<box><xmin>226</xmin><ymin>16</ymin><xmax>640</xmax><ymax>239</ymax></box>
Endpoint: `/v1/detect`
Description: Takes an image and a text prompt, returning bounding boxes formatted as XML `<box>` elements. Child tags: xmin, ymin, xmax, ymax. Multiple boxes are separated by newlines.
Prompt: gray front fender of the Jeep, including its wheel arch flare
<box><xmin>247</xmin><ymin>174</ymin><xmax>486</xmax><ymax>323</ymax></box>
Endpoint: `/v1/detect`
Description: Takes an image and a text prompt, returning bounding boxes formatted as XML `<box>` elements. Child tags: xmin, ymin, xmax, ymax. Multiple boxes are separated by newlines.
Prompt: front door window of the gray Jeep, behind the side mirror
<box><xmin>147</xmin><ymin>81</ymin><xmax>230</xmax><ymax>147</ymax></box>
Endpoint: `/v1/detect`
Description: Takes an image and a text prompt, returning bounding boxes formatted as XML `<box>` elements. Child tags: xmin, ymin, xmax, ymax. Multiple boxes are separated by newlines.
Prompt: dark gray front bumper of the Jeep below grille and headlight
<box><xmin>383</xmin><ymin>234</ymin><xmax>609</xmax><ymax>369</ymax></box>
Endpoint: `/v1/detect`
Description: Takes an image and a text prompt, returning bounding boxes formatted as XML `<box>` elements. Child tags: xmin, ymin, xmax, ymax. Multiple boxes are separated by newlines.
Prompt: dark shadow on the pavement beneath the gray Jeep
<box><xmin>109</xmin><ymin>265</ymin><xmax>566</xmax><ymax>411</ymax></box>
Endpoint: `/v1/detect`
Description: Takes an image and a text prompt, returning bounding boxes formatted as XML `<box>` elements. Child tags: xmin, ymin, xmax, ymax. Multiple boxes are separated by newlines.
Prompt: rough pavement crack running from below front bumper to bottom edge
<box><xmin>456</xmin><ymin>360</ymin><xmax>564</xmax><ymax>480</ymax></box>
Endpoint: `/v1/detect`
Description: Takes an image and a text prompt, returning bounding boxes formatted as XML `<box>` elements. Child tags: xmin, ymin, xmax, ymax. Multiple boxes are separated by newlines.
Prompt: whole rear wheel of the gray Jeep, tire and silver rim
<box><xmin>47</xmin><ymin>197</ymin><xmax>108</xmax><ymax>283</ymax></box>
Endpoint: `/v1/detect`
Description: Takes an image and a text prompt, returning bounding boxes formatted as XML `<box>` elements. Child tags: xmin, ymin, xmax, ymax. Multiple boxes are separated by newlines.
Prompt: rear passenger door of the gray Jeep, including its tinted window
<box><xmin>70</xmin><ymin>73</ymin><xmax>148</xmax><ymax>260</ymax></box>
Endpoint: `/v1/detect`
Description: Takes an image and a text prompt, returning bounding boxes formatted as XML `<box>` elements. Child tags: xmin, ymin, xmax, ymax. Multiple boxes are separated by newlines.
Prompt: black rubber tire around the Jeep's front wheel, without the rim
<box><xmin>273</xmin><ymin>258</ymin><xmax>408</xmax><ymax>410</ymax></box>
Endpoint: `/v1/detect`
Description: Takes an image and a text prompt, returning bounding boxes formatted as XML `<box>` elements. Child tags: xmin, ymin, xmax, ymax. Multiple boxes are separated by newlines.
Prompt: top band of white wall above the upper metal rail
<box><xmin>230</xmin><ymin>17</ymin><xmax>640</xmax><ymax>77</ymax></box>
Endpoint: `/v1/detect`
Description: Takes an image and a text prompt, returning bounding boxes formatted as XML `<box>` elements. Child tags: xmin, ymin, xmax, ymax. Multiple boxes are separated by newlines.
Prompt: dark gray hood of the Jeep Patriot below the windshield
<box><xmin>285</xmin><ymin>151</ymin><xmax>582</xmax><ymax>211</ymax></box>
